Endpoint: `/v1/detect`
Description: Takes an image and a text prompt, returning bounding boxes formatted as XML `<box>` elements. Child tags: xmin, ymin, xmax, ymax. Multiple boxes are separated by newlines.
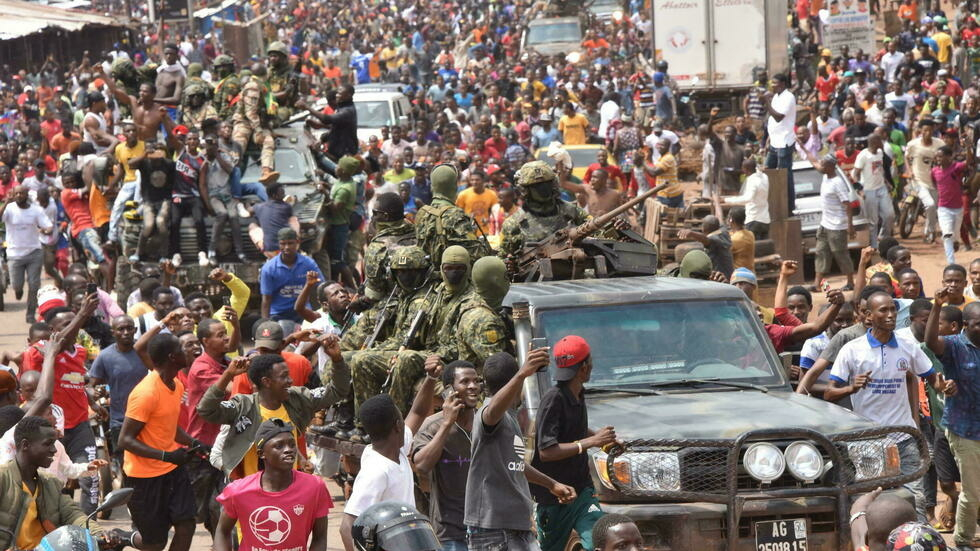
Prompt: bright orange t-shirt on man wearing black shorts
<box><xmin>123</xmin><ymin>371</ymin><xmax>184</xmax><ymax>478</ymax></box>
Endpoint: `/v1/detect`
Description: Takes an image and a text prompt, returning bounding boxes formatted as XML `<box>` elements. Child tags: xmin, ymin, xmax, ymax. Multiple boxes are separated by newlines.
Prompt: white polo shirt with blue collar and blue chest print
<box><xmin>830</xmin><ymin>333</ymin><xmax>933</xmax><ymax>428</ymax></box>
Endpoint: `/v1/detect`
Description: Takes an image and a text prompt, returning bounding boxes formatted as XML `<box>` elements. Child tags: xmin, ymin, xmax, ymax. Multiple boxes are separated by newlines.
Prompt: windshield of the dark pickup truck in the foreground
<box><xmin>537</xmin><ymin>300</ymin><xmax>782</xmax><ymax>387</ymax></box>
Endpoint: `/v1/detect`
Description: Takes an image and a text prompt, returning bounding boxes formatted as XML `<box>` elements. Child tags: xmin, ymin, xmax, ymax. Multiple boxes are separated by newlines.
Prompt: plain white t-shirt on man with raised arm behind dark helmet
<box><xmin>344</xmin><ymin>427</ymin><xmax>415</xmax><ymax>516</ymax></box>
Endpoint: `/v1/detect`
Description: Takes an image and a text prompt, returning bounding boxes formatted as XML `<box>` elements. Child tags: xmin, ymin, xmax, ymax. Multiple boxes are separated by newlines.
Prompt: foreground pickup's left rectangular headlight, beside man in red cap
<box><xmin>592</xmin><ymin>452</ymin><xmax>681</xmax><ymax>492</ymax></box>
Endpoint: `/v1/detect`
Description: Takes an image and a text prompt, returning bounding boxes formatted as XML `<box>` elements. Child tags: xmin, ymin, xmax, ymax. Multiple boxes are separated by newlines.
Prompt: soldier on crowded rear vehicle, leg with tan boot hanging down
<box><xmin>231</xmin><ymin>63</ymin><xmax>279</xmax><ymax>186</ymax></box>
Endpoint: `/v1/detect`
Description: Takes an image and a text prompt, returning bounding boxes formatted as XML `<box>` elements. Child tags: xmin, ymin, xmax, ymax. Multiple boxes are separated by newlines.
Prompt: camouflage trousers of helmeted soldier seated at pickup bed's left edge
<box><xmin>350</xmin><ymin>350</ymin><xmax>425</xmax><ymax>414</ymax></box>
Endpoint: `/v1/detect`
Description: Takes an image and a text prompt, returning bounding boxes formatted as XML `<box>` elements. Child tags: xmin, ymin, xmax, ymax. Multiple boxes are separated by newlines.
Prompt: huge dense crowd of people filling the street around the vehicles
<box><xmin>0</xmin><ymin>0</ymin><xmax>980</xmax><ymax>551</ymax></box>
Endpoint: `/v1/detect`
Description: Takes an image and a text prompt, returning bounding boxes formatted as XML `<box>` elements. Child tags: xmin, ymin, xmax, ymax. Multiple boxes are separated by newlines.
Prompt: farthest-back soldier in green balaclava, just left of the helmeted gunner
<box><xmin>415</xmin><ymin>165</ymin><xmax>490</xmax><ymax>261</ymax></box>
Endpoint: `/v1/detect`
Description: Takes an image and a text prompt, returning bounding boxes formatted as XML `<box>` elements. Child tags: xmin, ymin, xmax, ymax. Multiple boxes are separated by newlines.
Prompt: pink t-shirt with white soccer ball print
<box><xmin>218</xmin><ymin>471</ymin><xmax>333</xmax><ymax>551</ymax></box>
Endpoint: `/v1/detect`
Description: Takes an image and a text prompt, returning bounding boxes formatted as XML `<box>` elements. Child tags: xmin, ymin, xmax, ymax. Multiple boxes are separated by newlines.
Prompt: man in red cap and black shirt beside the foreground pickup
<box><xmin>531</xmin><ymin>335</ymin><xmax>616</xmax><ymax>551</ymax></box>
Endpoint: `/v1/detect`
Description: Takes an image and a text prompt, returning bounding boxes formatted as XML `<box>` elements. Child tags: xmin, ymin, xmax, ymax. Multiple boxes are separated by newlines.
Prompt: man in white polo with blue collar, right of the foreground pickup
<box><xmin>824</xmin><ymin>293</ymin><xmax>956</xmax><ymax>522</ymax></box>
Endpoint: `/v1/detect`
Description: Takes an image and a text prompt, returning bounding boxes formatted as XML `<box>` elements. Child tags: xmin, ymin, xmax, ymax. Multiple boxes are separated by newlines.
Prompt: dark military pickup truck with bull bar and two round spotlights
<box><xmin>505</xmin><ymin>277</ymin><xmax>929</xmax><ymax>551</ymax></box>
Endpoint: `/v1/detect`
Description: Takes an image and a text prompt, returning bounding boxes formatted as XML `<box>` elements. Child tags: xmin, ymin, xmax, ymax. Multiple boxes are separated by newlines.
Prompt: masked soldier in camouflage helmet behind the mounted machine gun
<box><xmin>500</xmin><ymin>161</ymin><xmax>588</xmax><ymax>259</ymax></box>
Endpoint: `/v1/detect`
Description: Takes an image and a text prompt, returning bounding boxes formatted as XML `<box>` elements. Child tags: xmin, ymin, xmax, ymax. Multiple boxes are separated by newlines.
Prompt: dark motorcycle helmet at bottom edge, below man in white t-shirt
<box><xmin>352</xmin><ymin>501</ymin><xmax>442</xmax><ymax>551</ymax></box>
